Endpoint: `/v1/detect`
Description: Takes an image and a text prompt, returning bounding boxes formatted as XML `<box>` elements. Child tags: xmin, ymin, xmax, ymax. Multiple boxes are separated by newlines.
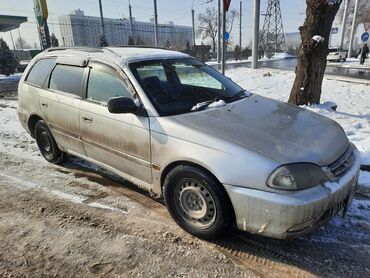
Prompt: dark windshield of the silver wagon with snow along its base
<box><xmin>130</xmin><ymin>58</ymin><xmax>247</xmax><ymax>116</ymax></box>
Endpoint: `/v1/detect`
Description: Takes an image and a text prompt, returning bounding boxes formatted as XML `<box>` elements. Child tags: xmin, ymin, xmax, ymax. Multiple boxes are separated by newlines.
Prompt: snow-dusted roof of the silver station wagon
<box><xmin>38</xmin><ymin>46</ymin><xmax>190</xmax><ymax>67</ymax></box>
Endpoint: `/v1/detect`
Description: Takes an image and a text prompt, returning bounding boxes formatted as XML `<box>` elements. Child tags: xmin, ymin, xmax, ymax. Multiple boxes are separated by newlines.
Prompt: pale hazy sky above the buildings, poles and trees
<box><xmin>0</xmin><ymin>0</ymin><xmax>328</xmax><ymax>47</ymax></box>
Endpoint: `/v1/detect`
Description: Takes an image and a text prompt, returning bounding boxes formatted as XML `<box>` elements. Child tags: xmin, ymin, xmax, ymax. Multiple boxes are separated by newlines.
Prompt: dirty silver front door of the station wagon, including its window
<box><xmin>80</xmin><ymin>62</ymin><xmax>152</xmax><ymax>184</ymax></box>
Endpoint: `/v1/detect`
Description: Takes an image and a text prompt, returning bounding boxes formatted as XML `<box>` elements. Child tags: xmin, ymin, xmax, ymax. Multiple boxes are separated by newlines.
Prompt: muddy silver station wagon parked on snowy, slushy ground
<box><xmin>18</xmin><ymin>47</ymin><xmax>360</xmax><ymax>239</ymax></box>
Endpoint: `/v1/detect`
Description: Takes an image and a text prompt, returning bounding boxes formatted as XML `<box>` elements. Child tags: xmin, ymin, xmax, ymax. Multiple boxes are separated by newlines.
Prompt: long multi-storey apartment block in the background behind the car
<box><xmin>58</xmin><ymin>9</ymin><xmax>192</xmax><ymax>48</ymax></box>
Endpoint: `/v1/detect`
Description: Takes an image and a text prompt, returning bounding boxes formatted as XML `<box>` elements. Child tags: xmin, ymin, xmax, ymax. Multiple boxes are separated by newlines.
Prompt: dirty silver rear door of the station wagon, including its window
<box><xmin>40</xmin><ymin>64</ymin><xmax>86</xmax><ymax>155</ymax></box>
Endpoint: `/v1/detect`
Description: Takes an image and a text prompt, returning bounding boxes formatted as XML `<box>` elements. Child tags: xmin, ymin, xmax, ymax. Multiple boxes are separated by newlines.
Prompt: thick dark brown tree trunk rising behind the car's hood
<box><xmin>288</xmin><ymin>0</ymin><xmax>342</xmax><ymax>105</ymax></box>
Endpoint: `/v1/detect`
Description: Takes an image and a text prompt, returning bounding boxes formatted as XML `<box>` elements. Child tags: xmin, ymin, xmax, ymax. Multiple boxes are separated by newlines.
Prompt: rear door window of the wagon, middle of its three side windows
<box><xmin>49</xmin><ymin>65</ymin><xmax>85</xmax><ymax>96</ymax></box>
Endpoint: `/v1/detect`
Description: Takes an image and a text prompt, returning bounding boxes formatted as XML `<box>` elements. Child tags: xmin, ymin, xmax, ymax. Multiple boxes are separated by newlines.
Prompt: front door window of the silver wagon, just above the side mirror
<box><xmin>87</xmin><ymin>67</ymin><xmax>132</xmax><ymax>102</ymax></box>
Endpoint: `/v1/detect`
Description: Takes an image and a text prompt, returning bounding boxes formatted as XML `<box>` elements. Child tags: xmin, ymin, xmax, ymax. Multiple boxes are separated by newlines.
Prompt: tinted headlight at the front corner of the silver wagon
<box><xmin>267</xmin><ymin>163</ymin><xmax>328</xmax><ymax>191</ymax></box>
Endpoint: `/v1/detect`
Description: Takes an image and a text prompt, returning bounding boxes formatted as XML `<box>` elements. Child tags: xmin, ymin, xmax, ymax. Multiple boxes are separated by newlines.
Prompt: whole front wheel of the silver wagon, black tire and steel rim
<box><xmin>163</xmin><ymin>165</ymin><xmax>232</xmax><ymax>239</ymax></box>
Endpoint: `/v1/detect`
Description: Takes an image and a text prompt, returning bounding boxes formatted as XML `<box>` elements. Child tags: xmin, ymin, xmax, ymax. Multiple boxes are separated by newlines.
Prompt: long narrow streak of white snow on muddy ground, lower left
<box><xmin>0</xmin><ymin>173</ymin><xmax>128</xmax><ymax>214</ymax></box>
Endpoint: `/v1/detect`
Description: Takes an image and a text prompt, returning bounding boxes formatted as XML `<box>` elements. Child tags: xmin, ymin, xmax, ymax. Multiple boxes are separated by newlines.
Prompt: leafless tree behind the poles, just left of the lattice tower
<box><xmin>197</xmin><ymin>8</ymin><xmax>238</xmax><ymax>51</ymax></box>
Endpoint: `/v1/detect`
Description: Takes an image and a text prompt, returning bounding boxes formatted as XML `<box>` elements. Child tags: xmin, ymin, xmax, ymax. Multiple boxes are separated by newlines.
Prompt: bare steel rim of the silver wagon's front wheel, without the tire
<box><xmin>175</xmin><ymin>179</ymin><xmax>216</xmax><ymax>229</ymax></box>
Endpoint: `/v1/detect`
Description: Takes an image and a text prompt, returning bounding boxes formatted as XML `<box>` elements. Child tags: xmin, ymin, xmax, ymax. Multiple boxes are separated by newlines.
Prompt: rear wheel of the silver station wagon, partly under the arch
<box><xmin>35</xmin><ymin>120</ymin><xmax>65</xmax><ymax>164</ymax></box>
